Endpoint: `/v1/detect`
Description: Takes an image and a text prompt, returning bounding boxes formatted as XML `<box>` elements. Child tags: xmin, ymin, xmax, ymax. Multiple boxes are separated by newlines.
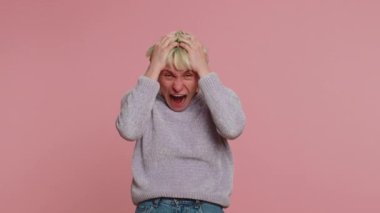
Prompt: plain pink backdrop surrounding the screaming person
<box><xmin>0</xmin><ymin>0</ymin><xmax>380</xmax><ymax>213</ymax></box>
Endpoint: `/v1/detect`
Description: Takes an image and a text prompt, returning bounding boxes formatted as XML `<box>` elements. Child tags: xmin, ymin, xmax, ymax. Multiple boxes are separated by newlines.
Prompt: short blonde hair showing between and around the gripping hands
<box><xmin>146</xmin><ymin>30</ymin><xmax>207</xmax><ymax>71</ymax></box>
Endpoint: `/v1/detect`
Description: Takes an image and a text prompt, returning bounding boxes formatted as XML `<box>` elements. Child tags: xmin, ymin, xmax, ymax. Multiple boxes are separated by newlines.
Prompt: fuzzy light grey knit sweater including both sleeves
<box><xmin>116</xmin><ymin>73</ymin><xmax>245</xmax><ymax>207</ymax></box>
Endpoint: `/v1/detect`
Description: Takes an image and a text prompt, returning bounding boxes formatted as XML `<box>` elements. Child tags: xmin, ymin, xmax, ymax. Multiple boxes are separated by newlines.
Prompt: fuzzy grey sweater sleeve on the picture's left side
<box><xmin>116</xmin><ymin>76</ymin><xmax>160</xmax><ymax>141</ymax></box>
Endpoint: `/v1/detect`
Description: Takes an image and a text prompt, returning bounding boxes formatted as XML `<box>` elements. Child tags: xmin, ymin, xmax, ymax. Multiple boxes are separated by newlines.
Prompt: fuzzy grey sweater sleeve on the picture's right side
<box><xmin>199</xmin><ymin>73</ymin><xmax>246</xmax><ymax>139</ymax></box>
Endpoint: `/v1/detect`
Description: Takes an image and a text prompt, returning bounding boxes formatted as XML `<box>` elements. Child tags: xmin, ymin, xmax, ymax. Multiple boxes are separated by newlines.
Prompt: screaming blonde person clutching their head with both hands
<box><xmin>116</xmin><ymin>31</ymin><xmax>245</xmax><ymax>213</ymax></box>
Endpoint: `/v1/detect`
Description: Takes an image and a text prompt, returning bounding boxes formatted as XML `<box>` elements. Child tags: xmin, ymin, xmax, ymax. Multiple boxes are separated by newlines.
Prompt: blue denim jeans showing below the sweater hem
<box><xmin>135</xmin><ymin>198</ymin><xmax>224</xmax><ymax>213</ymax></box>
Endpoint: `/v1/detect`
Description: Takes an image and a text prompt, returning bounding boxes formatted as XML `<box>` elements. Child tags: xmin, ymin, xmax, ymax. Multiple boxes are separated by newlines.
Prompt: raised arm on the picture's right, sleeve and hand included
<box><xmin>179</xmin><ymin>36</ymin><xmax>245</xmax><ymax>139</ymax></box>
